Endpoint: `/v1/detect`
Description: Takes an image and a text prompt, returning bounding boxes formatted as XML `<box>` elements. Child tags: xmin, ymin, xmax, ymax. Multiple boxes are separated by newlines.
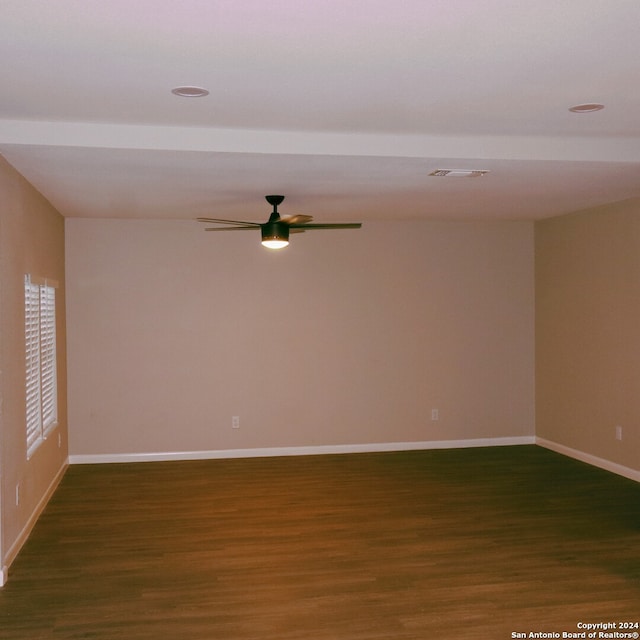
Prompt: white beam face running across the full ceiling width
<box><xmin>0</xmin><ymin>119</ymin><xmax>640</xmax><ymax>162</ymax></box>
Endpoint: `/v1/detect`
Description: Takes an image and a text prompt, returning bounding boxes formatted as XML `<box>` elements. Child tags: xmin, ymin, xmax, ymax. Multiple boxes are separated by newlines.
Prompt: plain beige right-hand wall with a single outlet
<box><xmin>536</xmin><ymin>199</ymin><xmax>640</xmax><ymax>471</ymax></box>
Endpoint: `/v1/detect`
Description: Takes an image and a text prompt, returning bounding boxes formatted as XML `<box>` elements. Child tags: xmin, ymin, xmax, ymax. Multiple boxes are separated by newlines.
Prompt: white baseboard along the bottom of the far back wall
<box><xmin>69</xmin><ymin>436</ymin><xmax>535</xmax><ymax>464</ymax></box>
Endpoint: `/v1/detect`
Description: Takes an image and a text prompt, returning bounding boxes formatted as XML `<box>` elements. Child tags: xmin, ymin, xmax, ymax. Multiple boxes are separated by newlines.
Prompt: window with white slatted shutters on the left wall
<box><xmin>24</xmin><ymin>276</ymin><xmax>58</xmax><ymax>457</ymax></box>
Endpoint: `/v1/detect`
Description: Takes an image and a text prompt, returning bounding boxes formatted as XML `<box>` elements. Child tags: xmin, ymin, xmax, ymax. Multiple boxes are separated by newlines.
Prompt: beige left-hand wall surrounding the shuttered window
<box><xmin>0</xmin><ymin>157</ymin><xmax>67</xmax><ymax>582</ymax></box>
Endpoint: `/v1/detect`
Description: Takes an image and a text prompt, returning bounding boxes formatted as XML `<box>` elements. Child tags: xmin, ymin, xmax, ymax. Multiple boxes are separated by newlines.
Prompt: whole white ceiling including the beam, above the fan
<box><xmin>0</xmin><ymin>0</ymin><xmax>640</xmax><ymax>221</ymax></box>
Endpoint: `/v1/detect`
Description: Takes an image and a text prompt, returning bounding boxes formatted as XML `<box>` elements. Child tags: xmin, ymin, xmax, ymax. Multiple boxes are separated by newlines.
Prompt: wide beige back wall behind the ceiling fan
<box><xmin>66</xmin><ymin>219</ymin><xmax>534</xmax><ymax>456</ymax></box>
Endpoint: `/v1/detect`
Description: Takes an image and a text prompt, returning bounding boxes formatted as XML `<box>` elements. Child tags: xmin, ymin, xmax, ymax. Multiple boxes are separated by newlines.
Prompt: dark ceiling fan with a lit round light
<box><xmin>198</xmin><ymin>196</ymin><xmax>362</xmax><ymax>249</ymax></box>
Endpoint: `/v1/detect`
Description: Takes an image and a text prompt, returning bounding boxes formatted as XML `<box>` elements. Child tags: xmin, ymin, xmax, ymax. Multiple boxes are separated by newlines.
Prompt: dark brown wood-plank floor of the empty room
<box><xmin>0</xmin><ymin>446</ymin><xmax>640</xmax><ymax>640</ymax></box>
